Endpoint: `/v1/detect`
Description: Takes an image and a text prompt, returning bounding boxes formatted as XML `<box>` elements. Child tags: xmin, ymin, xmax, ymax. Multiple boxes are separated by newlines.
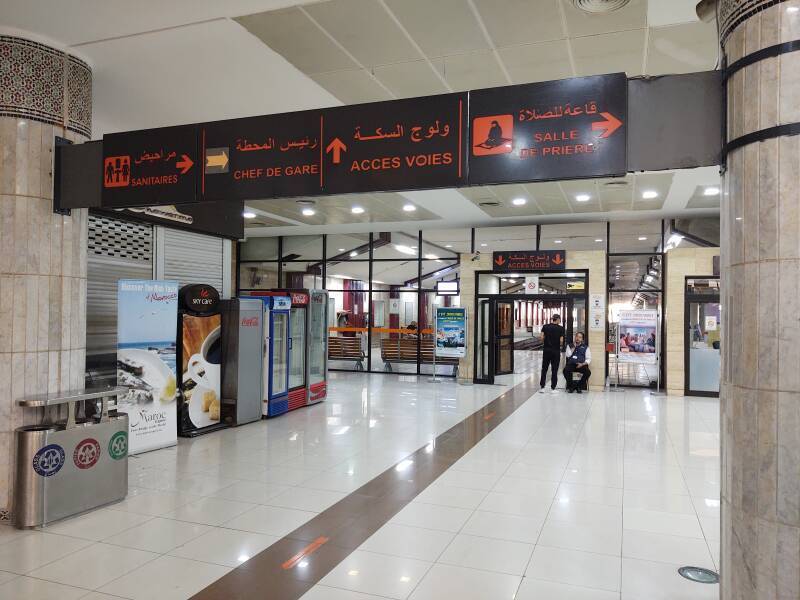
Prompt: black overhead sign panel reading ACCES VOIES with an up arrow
<box><xmin>322</xmin><ymin>93</ymin><xmax>467</xmax><ymax>194</ymax></box>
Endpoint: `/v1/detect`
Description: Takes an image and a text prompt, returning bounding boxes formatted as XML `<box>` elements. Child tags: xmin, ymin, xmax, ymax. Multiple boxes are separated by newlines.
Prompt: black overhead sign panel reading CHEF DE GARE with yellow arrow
<box><xmin>200</xmin><ymin>110</ymin><xmax>322</xmax><ymax>200</ymax></box>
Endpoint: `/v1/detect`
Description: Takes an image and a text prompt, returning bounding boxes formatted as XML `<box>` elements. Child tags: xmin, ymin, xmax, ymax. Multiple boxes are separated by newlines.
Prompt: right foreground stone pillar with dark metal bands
<box><xmin>717</xmin><ymin>0</ymin><xmax>800</xmax><ymax>600</ymax></box>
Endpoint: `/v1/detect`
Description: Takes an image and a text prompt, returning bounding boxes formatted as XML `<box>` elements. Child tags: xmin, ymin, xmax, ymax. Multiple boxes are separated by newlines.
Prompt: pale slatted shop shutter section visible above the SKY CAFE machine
<box><xmin>164</xmin><ymin>228</ymin><xmax>224</xmax><ymax>294</ymax></box>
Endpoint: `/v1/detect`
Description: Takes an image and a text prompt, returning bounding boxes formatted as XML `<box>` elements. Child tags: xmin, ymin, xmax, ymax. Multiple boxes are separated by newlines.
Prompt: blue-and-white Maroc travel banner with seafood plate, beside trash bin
<box><xmin>117</xmin><ymin>279</ymin><xmax>178</xmax><ymax>454</ymax></box>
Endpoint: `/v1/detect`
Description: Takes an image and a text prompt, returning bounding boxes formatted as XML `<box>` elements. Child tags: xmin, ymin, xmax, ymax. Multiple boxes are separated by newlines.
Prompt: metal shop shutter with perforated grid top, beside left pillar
<box><xmin>86</xmin><ymin>215</ymin><xmax>154</xmax><ymax>365</ymax></box>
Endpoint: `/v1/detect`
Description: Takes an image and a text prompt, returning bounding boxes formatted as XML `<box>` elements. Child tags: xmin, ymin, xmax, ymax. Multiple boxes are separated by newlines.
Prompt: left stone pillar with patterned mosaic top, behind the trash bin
<box><xmin>0</xmin><ymin>36</ymin><xmax>92</xmax><ymax>517</ymax></box>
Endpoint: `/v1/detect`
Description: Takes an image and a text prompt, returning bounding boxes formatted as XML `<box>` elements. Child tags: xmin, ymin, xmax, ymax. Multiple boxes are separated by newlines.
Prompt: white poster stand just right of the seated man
<box><xmin>616</xmin><ymin>309</ymin><xmax>661</xmax><ymax>388</ymax></box>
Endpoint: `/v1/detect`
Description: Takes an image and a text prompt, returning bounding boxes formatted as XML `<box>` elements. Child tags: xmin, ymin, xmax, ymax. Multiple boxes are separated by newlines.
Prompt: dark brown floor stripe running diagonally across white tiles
<box><xmin>192</xmin><ymin>377</ymin><xmax>538</xmax><ymax>600</ymax></box>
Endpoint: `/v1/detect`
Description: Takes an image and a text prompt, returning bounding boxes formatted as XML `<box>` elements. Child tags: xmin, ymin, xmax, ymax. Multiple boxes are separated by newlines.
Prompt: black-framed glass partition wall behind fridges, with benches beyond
<box><xmin>239</xmin><ymin>229</ymin><xmax>456</xmax><ymax>376</ymax></box>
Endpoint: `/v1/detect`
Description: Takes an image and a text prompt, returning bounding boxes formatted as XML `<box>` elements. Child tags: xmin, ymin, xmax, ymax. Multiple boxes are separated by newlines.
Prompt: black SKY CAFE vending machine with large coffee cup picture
<box><xmin>177</xmin><ymin>284</ymin><xmax>226</xmax><ymax>437</ymax></box>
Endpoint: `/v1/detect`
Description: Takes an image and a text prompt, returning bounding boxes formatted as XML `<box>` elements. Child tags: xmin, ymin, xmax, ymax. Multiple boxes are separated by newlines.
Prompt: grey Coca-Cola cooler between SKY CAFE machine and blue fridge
<box><xmin>220</xmin><ymin>298</ymin><xmax>264</xmax><ymax>427</ymax></box>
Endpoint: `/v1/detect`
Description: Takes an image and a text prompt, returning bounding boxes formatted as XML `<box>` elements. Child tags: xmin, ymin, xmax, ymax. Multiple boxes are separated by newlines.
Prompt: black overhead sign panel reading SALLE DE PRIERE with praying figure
<box><xmin>469</xmin><ymin>73</ymin><xmax>627</xmax><ymax>184</ymax></box>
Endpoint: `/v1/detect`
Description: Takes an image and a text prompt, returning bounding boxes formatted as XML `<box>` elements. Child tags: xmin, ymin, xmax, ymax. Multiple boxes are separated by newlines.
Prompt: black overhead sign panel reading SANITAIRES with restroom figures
<box><xmin>102</xmin><ymin>125</ymin><xmax>199</xmax><ymax>208</ymax></box>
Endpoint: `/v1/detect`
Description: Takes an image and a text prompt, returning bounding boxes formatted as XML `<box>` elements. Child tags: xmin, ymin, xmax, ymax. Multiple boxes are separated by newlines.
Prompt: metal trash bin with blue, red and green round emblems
<box><xmin>12</xmin><ymin>388</ymin><xmax>128</xmax><ymax>528</ymax></box>
